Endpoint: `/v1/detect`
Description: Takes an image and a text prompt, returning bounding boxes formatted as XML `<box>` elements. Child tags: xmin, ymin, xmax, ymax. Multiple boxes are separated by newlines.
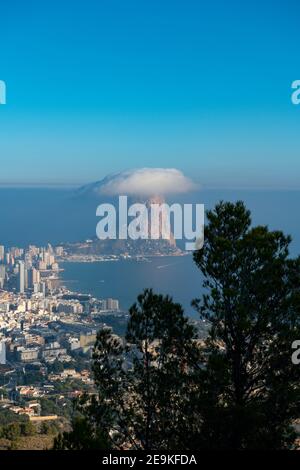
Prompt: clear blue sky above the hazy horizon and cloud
<box><xmin>0</xmin><ymin>0</ymin><xmax>300</xmax><ymax>188</ymax></box>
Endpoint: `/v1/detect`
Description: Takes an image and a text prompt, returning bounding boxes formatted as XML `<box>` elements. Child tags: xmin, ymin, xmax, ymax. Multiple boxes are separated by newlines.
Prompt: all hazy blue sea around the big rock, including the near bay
<box><xmin>0</xmin><ymin>188</ymin><xmax>300</xmax><ymax>315</ymax></box>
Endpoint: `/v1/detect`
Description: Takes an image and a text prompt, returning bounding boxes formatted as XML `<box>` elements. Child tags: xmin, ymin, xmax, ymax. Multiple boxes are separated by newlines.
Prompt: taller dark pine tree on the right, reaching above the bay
<box><xmin>194</xmin><ymin>202</ymin><xmax>300</xmax><ymax>449</ymax></box>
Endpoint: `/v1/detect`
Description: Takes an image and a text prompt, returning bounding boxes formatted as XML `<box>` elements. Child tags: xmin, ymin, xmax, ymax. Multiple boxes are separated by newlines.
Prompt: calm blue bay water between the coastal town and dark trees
<box><xmin>61</xmin><ymin>255</ymin><xmax>202</xmax><ymax>318</ymax></box>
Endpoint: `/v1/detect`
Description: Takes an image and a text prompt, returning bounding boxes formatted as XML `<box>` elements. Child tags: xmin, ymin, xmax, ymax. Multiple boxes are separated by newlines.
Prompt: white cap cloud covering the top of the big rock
<box><xmin>94</xmin><ymin>168</ymin><xmax>197</xmax><ymax>196</ymax></box>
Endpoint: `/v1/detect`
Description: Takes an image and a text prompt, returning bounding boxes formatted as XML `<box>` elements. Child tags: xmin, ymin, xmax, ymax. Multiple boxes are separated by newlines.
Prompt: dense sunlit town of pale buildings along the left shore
<box><xmin>0</xmin><ymin>245</ymin><xmax>125</xmax><ymax>422</ymax></box>
